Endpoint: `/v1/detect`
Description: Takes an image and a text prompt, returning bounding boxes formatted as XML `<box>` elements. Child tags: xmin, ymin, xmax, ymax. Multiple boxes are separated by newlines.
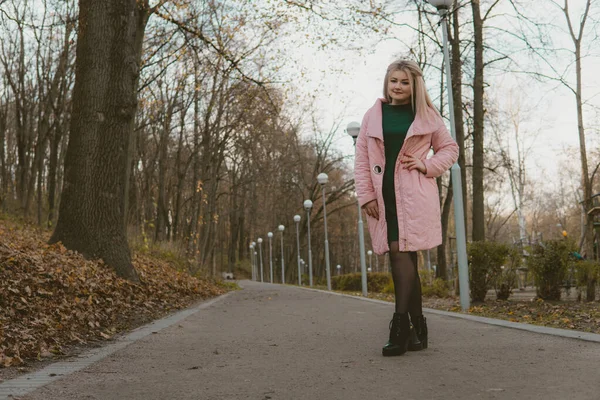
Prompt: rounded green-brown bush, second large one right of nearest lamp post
<box><xmin>527</xmin><ymin>240</ymin><xmax>575</xmax><ymax>300</ymax></box>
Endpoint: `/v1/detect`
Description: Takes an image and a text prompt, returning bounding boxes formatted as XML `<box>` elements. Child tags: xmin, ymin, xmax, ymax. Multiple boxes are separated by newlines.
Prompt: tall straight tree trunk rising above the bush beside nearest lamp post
<box><xmin>471</xmin><ymin>0</ymin><xmax>485</xmax><ymax>241</ymax></box>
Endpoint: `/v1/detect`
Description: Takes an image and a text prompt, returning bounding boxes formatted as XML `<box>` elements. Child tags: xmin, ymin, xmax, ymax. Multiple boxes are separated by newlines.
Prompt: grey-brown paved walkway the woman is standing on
<box><xmin>4</xmin><ymin>281</ymin><xmax>600</xmax><ymax>400</ymax></box>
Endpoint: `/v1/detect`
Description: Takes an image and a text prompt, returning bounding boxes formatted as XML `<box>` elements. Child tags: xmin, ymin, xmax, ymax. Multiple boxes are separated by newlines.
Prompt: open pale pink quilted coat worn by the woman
<box><xmin>354</xmin><ymin>99</ymin><xmax>458</xmax><ymax>254</ymax></box>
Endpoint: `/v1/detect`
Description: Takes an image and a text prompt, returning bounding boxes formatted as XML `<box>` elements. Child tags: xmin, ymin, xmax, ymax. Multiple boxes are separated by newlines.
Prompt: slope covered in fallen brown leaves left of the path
<box><xmin>0</xmin><ymin>218</ymin><xmax>226</xmax><ymax>367</ymax></box>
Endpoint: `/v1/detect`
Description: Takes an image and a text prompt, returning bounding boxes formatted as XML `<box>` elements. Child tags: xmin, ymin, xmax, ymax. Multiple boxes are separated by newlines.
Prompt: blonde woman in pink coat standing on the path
<box><xmin>354</xmin><ymin>60</ymin><xmax>458</xmax><ymax>356</ymax></box>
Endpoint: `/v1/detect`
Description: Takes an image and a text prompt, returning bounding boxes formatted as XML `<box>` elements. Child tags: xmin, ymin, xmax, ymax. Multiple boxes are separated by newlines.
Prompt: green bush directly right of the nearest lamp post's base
<box><xmin>467</xmin><ymin>242</ymin><xmax>510</xmax><ymax>301</ymax></box>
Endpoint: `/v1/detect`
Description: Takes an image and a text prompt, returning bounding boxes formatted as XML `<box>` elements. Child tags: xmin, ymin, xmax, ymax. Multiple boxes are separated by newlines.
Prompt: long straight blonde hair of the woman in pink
<box><xmin>383</xmin><ymin>60</ymin><xmax>437</xmax><ymax>119</ymax></box>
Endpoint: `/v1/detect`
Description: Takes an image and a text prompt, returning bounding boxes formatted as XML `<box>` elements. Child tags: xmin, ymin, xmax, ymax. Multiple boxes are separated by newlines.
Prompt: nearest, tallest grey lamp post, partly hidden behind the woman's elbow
<box><xmin>427</xmin><ymin>0</ymin><xmax>470</xmax><ymax>311</ymax></box>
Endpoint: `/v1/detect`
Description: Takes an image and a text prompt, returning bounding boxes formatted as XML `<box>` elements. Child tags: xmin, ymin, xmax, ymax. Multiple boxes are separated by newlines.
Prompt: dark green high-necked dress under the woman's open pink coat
<box><xmin>382</xmin><ymin>103</ymin><xmax>415</xmax><ymax>219</ymax></box>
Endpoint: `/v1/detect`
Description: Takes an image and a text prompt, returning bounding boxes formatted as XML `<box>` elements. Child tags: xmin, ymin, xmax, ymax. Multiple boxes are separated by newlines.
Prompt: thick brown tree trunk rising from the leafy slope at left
<box><xmin>50</xmin><ymin>0</ymin><xmax>148</xmax><ymax>281</ymax></box>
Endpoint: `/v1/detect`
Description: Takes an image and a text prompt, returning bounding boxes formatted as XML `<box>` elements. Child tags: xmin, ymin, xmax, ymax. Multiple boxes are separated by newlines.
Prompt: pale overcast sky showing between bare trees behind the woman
<box><xmin>276</xmin><ymin>0</ymin><xmax>600</xmax><ymax>194</ymax></box>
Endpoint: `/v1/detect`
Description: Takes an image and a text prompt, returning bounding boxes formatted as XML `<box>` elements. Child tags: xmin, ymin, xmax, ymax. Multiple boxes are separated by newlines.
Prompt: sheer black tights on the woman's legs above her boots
<box><xmin>390</xmin><ymin>242</ymin><xmax>423</xmax><ymax>317</ymax></box>
